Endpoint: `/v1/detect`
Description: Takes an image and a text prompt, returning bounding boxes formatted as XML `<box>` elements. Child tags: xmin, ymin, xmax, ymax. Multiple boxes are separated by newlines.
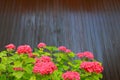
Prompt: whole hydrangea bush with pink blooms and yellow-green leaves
<box><xmin>0</xmin><ymin>42</ymin><xmax>103</xmax><ymax>80</ymax></box>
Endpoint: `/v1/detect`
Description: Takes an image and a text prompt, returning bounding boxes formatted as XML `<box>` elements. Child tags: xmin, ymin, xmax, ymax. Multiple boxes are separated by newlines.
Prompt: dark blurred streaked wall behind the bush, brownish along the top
<box><xmin>0</xmin><ymin>0</ymin><xmax>120</xmax><ymax>80</ymax></box>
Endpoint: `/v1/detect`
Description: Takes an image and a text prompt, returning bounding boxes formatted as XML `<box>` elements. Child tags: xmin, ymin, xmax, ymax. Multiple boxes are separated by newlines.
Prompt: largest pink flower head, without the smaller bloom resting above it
<box><xmin>33</xmin><ymin>62</ymin><xmax>57</xmax><ymax>75</ymax></box>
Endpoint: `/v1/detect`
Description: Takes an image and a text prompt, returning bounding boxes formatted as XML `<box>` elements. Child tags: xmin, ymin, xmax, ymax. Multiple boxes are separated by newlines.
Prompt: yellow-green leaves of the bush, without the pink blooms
<box><xmin>0</xmin><ymin>46</ymin><xmax>102</xmax><ymax>80</ymax></box>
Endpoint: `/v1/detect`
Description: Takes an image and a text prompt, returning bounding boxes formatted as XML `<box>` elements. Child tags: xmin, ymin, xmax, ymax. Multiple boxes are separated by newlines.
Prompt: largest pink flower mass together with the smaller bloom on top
<box><xmin>33</xmin><ymin>56</ymin><xmax>57</xmax><ymax>75</ymax></box>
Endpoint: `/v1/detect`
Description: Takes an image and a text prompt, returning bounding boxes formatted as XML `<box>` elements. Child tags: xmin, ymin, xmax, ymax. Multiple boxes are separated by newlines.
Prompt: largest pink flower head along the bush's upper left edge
<box><xmin>17</xmin><ymin>45</ymin><xmax>32</xmax><ymax>54</ymax></box>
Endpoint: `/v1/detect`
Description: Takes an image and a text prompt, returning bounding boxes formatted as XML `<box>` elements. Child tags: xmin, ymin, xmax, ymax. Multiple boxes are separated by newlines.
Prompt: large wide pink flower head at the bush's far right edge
<box><xmin>80</xmin><ymin>62</ymin><xmax>103</xmax><ymax>73</ymax></box>
